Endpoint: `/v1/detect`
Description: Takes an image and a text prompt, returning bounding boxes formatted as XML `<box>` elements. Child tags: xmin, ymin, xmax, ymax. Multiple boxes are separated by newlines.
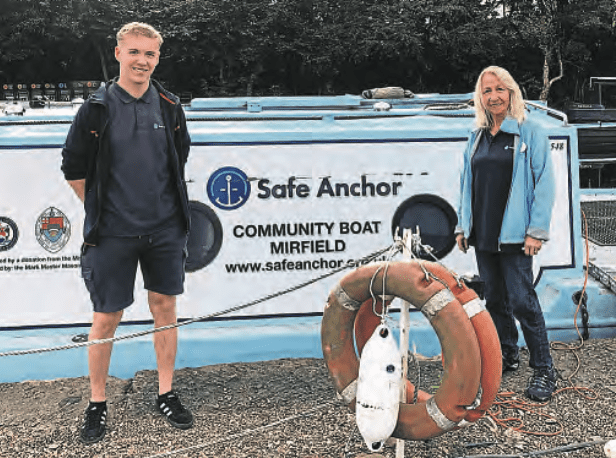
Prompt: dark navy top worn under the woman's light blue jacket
<box><xmin>469</xmin><ymin>129</ymin><xmax>521</xmax><ymax>252</ymax></box>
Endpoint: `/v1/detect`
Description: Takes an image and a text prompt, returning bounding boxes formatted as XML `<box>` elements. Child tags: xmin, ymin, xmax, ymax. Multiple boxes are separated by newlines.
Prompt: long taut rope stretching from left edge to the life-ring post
<box><xmin>0</xmin><ymin>242</ymin><xmax>394</xmax><ymax>358</ymax></box>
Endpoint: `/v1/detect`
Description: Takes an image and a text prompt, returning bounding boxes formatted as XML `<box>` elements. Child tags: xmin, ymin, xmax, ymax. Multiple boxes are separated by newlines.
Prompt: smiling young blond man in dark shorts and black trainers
<box><xmin>62</xmin><ymin>22</ymin><xmax>193</xmax><ymax>443</ymax></box>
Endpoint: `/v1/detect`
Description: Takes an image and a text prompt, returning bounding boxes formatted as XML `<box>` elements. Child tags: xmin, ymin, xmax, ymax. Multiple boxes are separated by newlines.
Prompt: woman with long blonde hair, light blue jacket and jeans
<box><xmin>456</xmin><ymin>67</ymin><xmax>556</xmax><ymax>402</ymax></box>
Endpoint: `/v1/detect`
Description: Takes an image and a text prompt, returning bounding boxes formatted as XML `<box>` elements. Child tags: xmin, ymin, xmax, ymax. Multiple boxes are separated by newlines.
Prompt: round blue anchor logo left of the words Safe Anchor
<box><xmin>207</xmin><ymin>167</ymin><xmax>250</xmax><ymax>210</ymax></box>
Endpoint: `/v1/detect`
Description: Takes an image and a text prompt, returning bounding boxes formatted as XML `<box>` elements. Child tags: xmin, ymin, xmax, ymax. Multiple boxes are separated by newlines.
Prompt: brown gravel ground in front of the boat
<box><xmin>0</xmin><ymin>339</ymin><xmax>616</xmax><ymax>458</ymax></box>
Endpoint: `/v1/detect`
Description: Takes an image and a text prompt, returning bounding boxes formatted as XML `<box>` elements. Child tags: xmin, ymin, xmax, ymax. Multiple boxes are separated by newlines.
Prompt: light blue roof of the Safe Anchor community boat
<box><xmin>0</xmin><ymin>93</ymin><xmax>567</xmax><ymax>147</ymax></box>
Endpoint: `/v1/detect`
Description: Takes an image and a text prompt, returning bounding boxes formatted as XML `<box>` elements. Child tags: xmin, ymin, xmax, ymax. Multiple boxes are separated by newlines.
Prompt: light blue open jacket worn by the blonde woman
<box><xmin>456</xmin><ymin>117</ymin><xmax>555</xmax><ymax>247</ymax></box>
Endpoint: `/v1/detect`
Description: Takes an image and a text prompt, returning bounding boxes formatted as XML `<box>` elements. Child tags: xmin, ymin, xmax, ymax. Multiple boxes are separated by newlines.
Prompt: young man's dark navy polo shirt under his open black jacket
<box><xmin>100</xmin><ymin>84</ymin><xmax>179</xmax><ymax>236</ymax></box>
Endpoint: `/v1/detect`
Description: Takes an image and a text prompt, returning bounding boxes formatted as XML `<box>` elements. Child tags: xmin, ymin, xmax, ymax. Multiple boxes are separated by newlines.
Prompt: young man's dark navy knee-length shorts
<box><xmin>81</xmin><ymin>224</ymin><xmax>187</xmax><ymax>313</ymax></box>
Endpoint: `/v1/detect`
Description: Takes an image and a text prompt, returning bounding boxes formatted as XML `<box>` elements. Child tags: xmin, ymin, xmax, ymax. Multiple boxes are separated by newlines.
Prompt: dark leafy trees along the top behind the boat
<box><xmin>0</xmin><ymin>0</ymin><xmax>616</xmax><ymax>104</ymax></box>
